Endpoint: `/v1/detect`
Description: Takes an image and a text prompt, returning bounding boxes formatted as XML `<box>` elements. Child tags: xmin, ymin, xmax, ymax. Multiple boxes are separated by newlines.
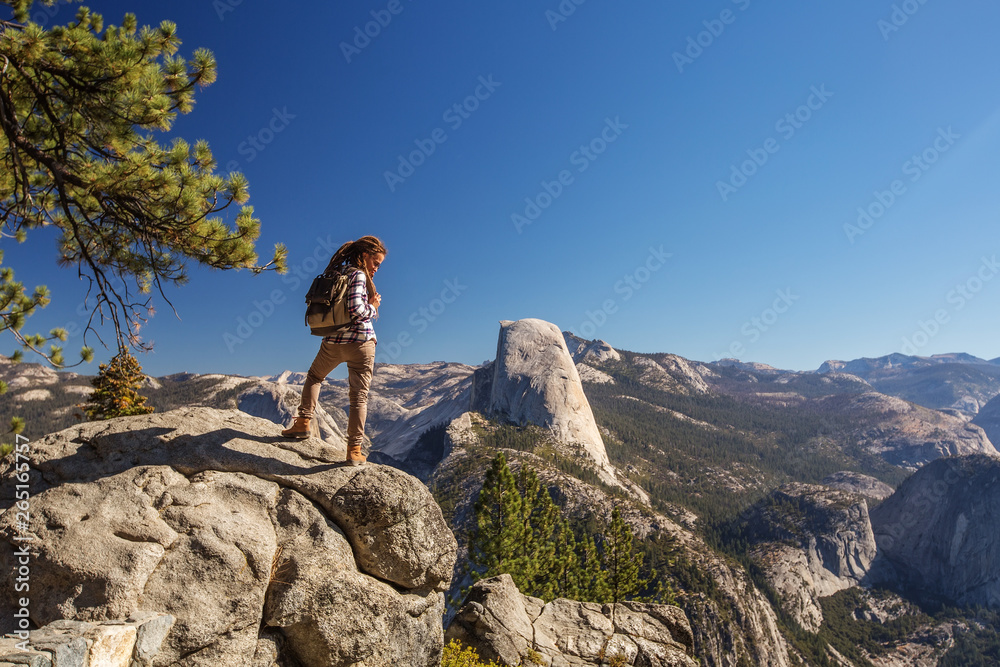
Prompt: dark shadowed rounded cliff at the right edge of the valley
<box><xmin>871</xmin><ymin>455</ymin><xmax>1000</xmax><ymax>608</ymax></box>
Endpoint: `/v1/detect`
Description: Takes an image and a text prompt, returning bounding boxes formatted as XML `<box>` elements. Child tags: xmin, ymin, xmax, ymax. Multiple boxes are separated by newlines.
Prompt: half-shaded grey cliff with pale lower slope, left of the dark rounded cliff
<box><xmin>746</xmin><ymin>484</ymin><xmax>876</xmax><ymax>632</ymax></box>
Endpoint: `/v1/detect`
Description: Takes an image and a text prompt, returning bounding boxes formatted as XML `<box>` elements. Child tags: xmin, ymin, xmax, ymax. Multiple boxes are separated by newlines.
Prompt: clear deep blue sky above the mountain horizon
<box><xmin>3</xmin><ymin>0</ymin><xmax>1000</xmax><ymax>375</ymax></box>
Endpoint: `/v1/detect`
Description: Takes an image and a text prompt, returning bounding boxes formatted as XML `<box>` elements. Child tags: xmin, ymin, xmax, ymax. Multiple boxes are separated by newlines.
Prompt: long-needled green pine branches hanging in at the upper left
<box><xmin>0</xmin><ymin>0</ymin><xmax>286</xmax><ymax>366</ymax></box>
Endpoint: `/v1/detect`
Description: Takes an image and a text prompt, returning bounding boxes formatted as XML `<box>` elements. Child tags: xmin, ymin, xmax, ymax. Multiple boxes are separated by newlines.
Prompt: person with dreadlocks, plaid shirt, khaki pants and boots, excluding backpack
<box><xmin>281</xmin><ymin>236</ymin><xmax>385</xmax><ymax>465</ymax></box>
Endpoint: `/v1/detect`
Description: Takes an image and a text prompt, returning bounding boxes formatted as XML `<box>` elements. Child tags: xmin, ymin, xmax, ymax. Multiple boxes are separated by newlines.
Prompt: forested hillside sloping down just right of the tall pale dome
<box><xmin>585</xmin><ymin>352</ymin><xmax>909</xmax><ymax>523</ymax></box>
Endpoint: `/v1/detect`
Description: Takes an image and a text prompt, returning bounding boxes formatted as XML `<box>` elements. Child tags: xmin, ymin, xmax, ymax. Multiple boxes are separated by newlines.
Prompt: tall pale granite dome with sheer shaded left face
<box><xmin>473</xmin><ymin>319</ymin><xmax>611</xmax><ymax>476</ymax></box>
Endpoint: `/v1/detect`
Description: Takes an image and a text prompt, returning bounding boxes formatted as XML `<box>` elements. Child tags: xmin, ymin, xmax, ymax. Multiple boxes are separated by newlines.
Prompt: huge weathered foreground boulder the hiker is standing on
<box><xmin>0</xmin><ymin>408</ymin><xmax>456</xmax><ymax>667</ymax></box>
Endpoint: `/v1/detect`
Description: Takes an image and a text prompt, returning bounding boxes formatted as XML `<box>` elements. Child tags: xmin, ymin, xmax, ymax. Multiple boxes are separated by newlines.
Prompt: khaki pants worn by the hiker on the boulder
<box><xmin>299</xmin><ymin>339</ymin><xmax>375</xmax><ymax>453</ymax></box>
